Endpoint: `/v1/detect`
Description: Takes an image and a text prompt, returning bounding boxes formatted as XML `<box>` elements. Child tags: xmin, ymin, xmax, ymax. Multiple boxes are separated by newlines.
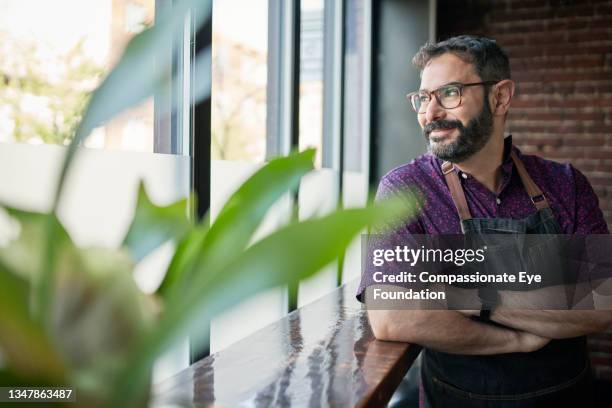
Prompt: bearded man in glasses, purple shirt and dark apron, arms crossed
<box><xmin>358</xmin><ymin>36</ymin><xmax>612</xmax><ymax>407</ymax></box>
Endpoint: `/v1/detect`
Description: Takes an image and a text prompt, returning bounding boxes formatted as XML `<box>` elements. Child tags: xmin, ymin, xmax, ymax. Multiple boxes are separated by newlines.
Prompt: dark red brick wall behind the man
<box><xmin>437</xmin><ymin>0</ymin><xmax>612</xmax><ymax>381</ymax></box>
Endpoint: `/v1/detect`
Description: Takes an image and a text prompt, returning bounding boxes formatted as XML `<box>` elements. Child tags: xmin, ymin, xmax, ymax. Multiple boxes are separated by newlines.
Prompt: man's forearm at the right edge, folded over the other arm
<box><xmin>491</xmin><ymin>309</ymin><xmax>612</xmax><ymax>339</ymax></box>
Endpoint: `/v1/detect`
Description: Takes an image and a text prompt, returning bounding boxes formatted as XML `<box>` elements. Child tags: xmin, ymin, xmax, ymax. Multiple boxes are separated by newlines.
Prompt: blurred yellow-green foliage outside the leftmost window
<box><xmin>0</xmin><ymin>34</ymin><xmax>104</xmax><ymax>144</ymax></box>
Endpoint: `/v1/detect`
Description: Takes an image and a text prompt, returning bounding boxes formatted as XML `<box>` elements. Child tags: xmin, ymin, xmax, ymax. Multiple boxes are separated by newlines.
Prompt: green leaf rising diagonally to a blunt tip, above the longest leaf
<box><xmin>159</xmin><ymin>149</ymin><xmax>315</xmax><ymax>297</ymax></box>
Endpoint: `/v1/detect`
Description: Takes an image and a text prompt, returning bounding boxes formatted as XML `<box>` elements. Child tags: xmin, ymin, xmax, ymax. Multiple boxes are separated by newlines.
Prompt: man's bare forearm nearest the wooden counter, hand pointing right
<box><xmin>368</xmin><ymin>310</ymin><xmax>546</xmax><ymax>354</ymax></box>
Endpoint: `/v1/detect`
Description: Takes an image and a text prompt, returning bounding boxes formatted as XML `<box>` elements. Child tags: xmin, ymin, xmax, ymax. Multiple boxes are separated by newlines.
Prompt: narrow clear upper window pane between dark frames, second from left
<box><xmin>211</xmin><ymin>0</ymin><xmax>268</xmax><ymax>162</ymax></box>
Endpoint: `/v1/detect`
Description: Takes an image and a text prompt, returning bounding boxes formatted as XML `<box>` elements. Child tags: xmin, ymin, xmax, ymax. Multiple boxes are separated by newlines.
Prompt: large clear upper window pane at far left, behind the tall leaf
<box><xmin>0</xmin><ymin>0</ymin><xmax>167</xmax><ymax>152</ymax></box>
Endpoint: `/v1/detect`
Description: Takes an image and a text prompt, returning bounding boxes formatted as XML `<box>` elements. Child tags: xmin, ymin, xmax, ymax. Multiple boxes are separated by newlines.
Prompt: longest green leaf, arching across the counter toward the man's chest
<box><xmin>112</xmin><ymin>196</ymin><xmax>414</xmax><ymax>401</ymax></box>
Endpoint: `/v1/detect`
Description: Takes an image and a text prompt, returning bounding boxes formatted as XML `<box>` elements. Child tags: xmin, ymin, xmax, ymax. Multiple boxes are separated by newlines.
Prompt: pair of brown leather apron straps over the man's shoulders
<box><xmin>442</xmin><ymin>151</ymin><xmax>549</xmax><ymax>220</ymax></box>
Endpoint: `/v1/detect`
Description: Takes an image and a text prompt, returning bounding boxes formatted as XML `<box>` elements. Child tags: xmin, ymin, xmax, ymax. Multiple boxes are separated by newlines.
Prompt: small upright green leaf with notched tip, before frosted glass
<box><xmin>123</xmin><ymin>182</ymin><xmax>190</xmax><ymax>262</ymax></box>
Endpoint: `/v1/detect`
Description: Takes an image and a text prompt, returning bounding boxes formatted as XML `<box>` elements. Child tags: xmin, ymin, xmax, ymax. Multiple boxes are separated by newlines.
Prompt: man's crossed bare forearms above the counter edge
<box><xmin>366</xmin><ymin>286</ymin><xmax>612</xmax><ymax>354</ymax></box>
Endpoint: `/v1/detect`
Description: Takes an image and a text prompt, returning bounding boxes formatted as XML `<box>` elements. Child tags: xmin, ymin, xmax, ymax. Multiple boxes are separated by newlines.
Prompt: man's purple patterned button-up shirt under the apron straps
<box><xmin>358</xmin><ymin>136</ymin><xmax>609</xmax><ymax>298</ymax></box>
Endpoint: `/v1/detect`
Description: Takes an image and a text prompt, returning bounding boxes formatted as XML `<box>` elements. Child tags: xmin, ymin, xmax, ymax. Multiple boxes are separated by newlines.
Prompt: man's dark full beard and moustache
<box><xmin>423</xmin><ymin>100</ymin><xmax>493</xmax><ymax>163</ymax></box>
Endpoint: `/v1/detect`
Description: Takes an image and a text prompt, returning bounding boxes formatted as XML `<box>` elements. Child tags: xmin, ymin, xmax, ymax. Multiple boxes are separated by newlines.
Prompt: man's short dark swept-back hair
<box><xmin>412</xmin><ymin>35</ymin><xmax>510</xmax><ymax>81</ymax></box>
